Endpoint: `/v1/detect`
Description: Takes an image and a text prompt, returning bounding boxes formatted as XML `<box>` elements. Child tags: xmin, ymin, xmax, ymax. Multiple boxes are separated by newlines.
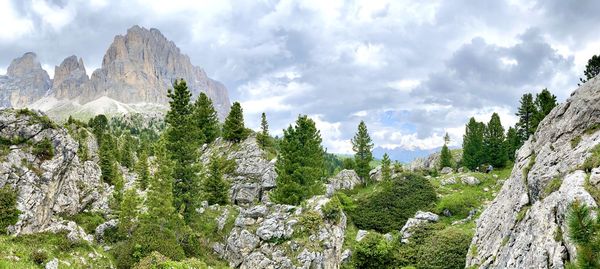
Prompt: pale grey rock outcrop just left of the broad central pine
<box><xmin>201</xmin><ymin>136</ymin><xmax>277</xmax><ymax>206</ymax></box>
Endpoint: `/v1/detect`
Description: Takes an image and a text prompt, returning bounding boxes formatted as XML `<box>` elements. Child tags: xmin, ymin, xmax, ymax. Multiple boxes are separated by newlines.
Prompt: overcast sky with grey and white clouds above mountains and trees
<box><xmin>0</xmin><ymin>0</ymin><xmax>600</xmax><ymax>159</ymax></box>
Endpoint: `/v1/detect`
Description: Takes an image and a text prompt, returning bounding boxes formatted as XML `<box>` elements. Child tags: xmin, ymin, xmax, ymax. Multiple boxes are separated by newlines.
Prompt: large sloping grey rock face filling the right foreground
<box><xmin>467</xmin><ymin>78</ymin><xmax>600</xmax><ymax>268</ymax></box>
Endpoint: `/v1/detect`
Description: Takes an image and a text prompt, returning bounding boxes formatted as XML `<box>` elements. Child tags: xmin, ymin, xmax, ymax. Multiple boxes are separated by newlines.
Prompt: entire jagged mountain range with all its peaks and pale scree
<box><xmin>0</xmin><ymin>25</ymin><xmax>230</xmax><ymax>119</ymax></box>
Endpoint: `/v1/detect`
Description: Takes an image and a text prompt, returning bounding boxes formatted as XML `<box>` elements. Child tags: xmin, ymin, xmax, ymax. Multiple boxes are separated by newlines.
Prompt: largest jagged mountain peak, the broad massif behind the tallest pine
<box><xmin>88</xmin><ymin>25</ymin><xmax>229</xmax><ymax>119</ymax></box>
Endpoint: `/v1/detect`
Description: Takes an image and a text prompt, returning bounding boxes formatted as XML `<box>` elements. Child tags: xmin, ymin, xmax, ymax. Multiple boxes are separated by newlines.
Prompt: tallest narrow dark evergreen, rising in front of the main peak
<box><xmin>166</xmin><ymin>80</ymin><xmax>204</xmax><ymax>218</ymax></box>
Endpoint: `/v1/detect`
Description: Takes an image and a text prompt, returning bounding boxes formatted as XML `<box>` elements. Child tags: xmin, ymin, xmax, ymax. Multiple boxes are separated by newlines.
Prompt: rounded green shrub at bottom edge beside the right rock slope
<box><xmin>417</xmin><ymin>228</ymin><xmax>471</xmax><ymax>269</ymax></box>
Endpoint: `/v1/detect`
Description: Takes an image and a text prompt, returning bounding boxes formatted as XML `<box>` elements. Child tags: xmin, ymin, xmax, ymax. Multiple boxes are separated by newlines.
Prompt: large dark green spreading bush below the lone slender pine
<box><xmin>345</xmin><ymin>173</ymin><xmax>437</xmax><ymax>233</ymax></box>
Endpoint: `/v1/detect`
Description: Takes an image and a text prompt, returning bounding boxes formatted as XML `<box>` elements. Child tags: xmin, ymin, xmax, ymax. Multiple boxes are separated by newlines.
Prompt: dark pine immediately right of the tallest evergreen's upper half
<box><xmin>192</xmin><ymin>92</ymin><xmax>221</xmax><ymax>143</ymax></box>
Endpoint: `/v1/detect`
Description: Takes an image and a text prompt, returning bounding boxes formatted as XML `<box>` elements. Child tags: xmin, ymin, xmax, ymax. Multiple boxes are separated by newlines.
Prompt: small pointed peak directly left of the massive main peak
<box><xmin>52</xmin><ymin>55</ymin><xmax>90</xmax><ymax>99</ymax></box>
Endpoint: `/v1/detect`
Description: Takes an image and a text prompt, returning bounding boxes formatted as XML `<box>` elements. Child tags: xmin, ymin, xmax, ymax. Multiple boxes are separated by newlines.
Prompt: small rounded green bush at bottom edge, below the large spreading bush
<box><xmin>352</xmin><ymin>233</ymin><xmax>394</xmax><ymax>269</ymax></box>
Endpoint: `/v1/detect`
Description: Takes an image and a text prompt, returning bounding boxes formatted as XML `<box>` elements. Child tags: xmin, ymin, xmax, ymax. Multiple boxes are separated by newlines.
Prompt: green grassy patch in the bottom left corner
<box><xmin>0</xmin><ymin>230</ymin><xmax>114</xmax><ymax>269</ymax></box>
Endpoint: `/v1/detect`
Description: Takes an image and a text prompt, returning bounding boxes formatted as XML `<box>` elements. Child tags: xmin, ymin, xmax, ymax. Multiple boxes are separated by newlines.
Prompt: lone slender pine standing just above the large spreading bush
<box><xmin>351</xmin><ymin>121</ymin><xmax>373</xmax><ymax>183</ymax></box>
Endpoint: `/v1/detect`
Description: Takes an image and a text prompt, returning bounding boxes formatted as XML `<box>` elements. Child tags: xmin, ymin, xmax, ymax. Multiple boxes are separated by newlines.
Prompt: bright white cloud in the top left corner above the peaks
<box><xmin>0</xmin><ymin>0</ymin><xmax>34</xmax><ymax>43</ymax></box>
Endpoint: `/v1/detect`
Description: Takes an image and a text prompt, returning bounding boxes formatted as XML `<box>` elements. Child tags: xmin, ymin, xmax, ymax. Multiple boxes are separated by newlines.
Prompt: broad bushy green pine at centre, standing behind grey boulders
<box><xmin>270</xmin><ymin>116</ymin><xmax>325</xmax><ymax>205</ymax></box>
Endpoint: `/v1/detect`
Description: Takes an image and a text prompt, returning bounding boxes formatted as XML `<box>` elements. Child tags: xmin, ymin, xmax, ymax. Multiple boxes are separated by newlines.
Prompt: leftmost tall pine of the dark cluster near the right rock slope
<box><xmin>462</xmin><ymin>118</ymin><xmax>485</xmax><ymax>170</ymax></box>
